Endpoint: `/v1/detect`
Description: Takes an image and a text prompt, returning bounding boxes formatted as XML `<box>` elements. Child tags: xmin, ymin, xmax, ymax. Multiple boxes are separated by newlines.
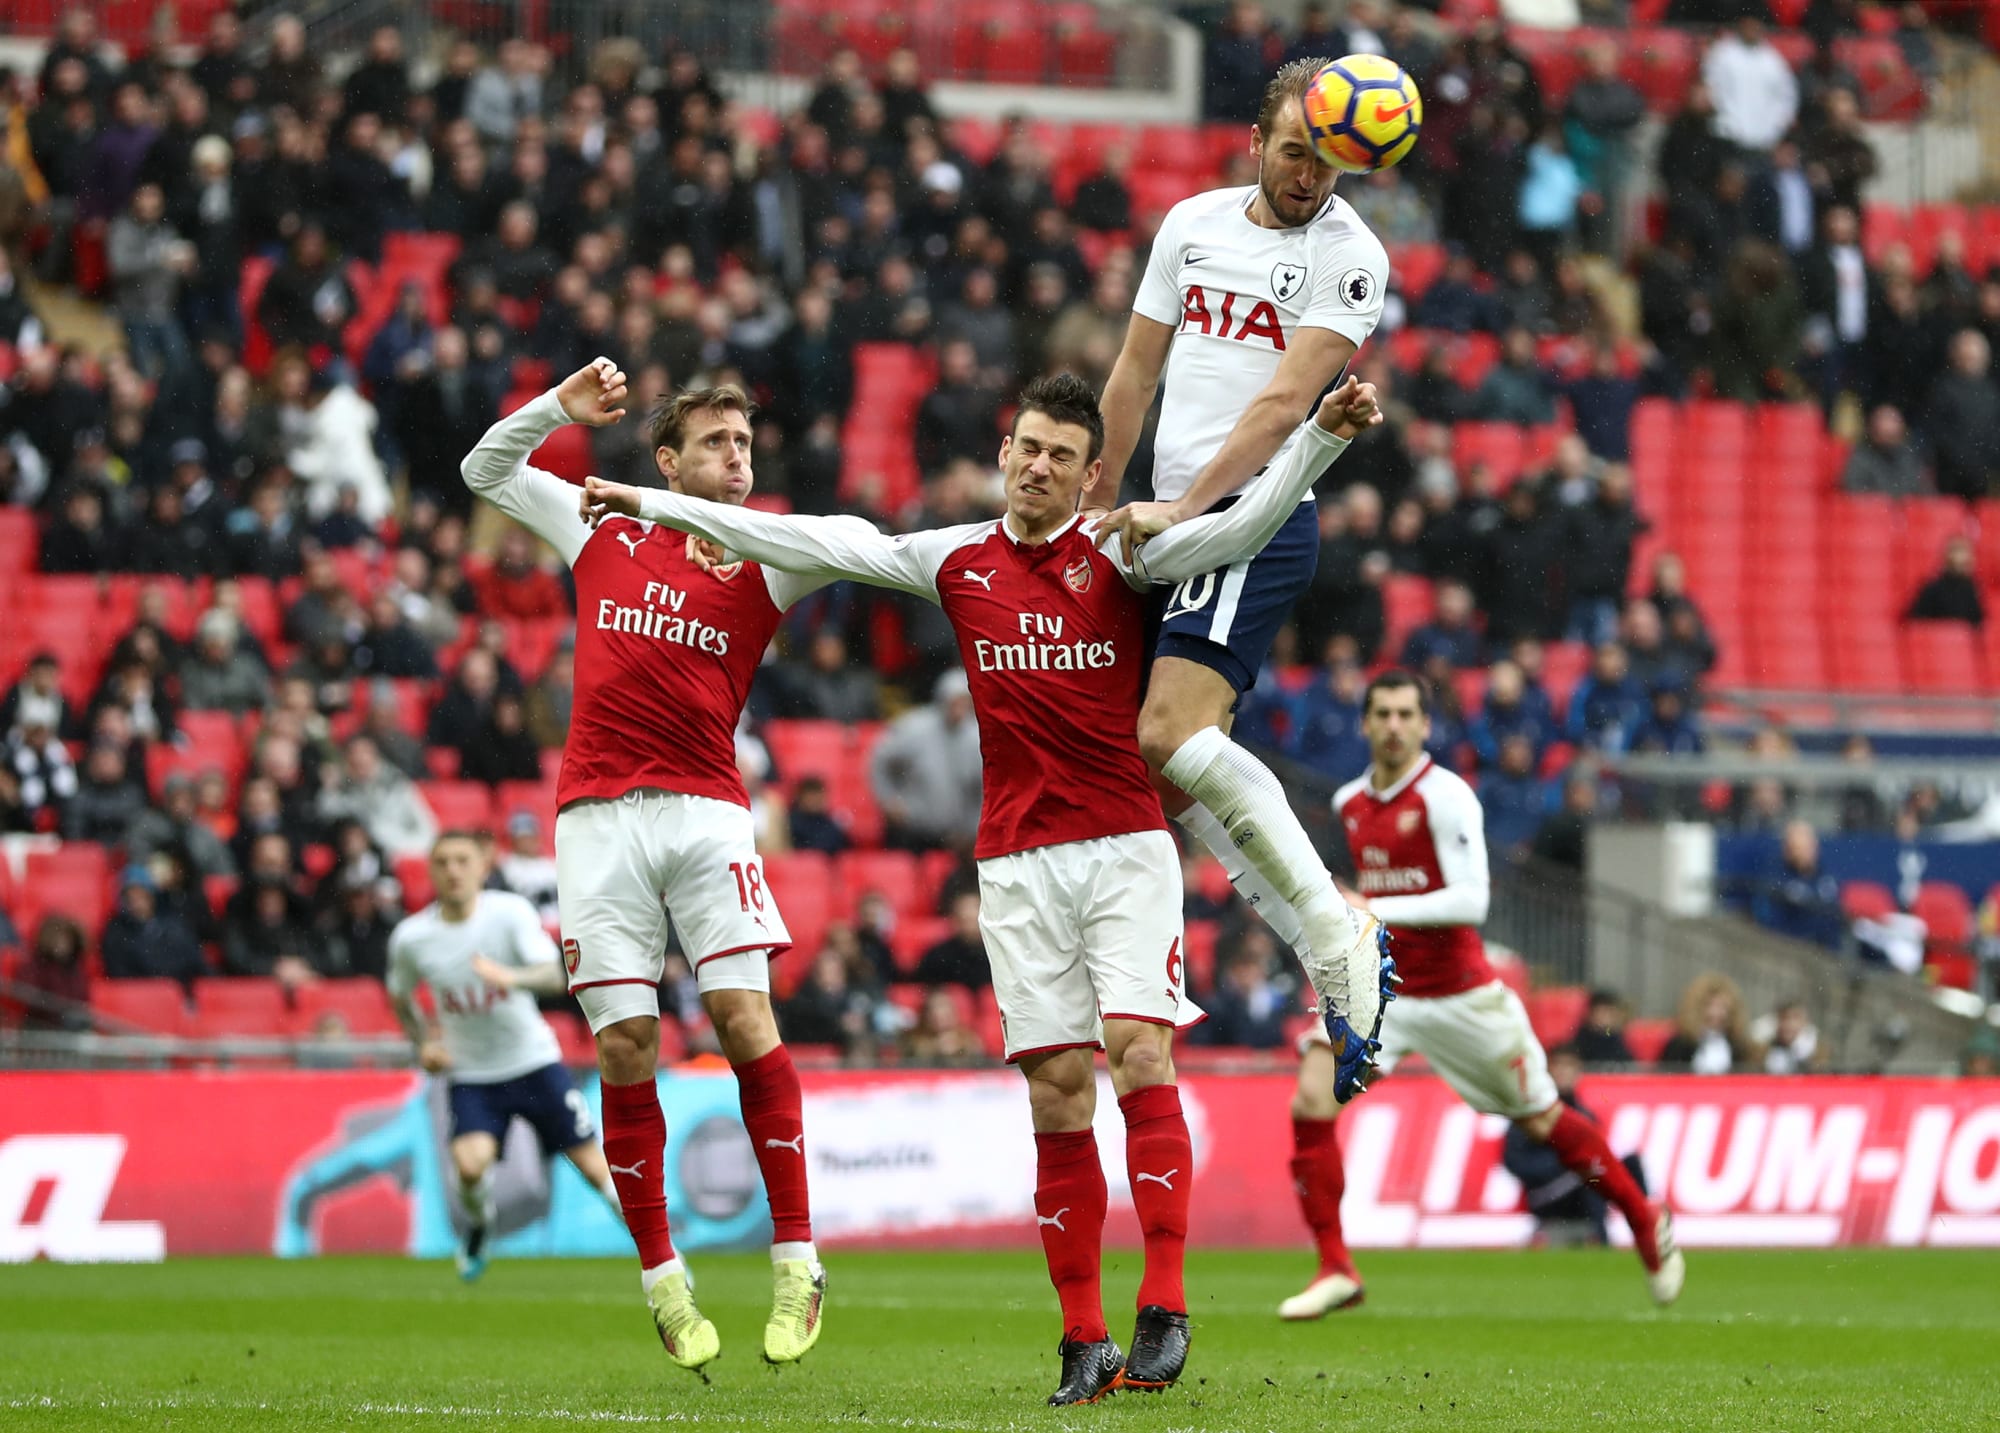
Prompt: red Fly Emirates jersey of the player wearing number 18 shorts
<box><xmin>462</xmin><ymin>390</ymin><xmax>830</xmax><ymax>807</ymax></box>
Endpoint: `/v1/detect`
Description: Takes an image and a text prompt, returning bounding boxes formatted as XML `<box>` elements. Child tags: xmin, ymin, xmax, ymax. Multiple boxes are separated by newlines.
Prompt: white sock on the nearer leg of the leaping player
<box><xmin>1160</xmin><ymin>727</ymin><xmax>1362</xmax><ymax>995</ymax></box>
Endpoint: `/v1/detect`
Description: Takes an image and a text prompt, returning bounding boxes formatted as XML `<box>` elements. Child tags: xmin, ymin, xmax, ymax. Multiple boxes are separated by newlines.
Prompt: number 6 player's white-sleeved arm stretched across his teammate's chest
<box><xmin>580</xmin><ymin>478</ymin><xmax>938</xmax><ymax>600</ymax></box>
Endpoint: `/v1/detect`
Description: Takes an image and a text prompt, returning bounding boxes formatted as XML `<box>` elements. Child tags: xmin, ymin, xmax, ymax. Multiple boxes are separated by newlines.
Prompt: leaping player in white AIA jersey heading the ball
<box><xmin>1094</xmin><ymin>60</ymin><xmax>1388</xmax><ymax>1101</ymax></box>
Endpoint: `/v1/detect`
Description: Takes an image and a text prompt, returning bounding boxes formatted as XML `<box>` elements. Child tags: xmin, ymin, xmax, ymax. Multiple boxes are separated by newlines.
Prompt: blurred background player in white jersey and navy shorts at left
<box><xmin>388</xmin><ymin>831</ymin><xmax>622</xmax><ymax>1279</ymax></box>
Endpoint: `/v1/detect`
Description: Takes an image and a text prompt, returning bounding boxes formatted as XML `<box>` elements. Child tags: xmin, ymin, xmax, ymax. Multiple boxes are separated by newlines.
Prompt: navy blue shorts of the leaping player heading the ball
<box><xmin>1154</xmin><ymin>496</ymin><xmax>1320</xmax><ymax>696</ymax></box>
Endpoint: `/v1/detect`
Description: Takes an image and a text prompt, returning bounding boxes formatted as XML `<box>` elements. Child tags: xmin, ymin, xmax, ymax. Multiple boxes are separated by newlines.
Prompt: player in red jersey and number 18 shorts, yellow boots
<box><xmin>462</xmin><ymin>358</ymin><xmax>840</xmax><ymax>1369</ymax></box>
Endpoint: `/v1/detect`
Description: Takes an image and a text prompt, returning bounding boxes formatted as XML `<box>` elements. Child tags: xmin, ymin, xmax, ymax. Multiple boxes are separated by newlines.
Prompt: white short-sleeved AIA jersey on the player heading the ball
<box><xmin>1132</xmin><ymin>184</ymin><xmax>1388</xmax><ymax>502</ymax></box>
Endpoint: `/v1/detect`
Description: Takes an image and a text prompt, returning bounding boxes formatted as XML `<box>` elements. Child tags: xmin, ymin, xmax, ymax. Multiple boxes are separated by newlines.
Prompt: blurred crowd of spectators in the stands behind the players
<box><xmin>0</xmin><ymin>0</ymin><xmax>2000</xmax><ymax>1059</ymax></box>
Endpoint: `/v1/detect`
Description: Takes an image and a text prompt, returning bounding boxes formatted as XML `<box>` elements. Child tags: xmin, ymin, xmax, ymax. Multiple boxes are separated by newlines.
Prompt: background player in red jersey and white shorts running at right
<box><xmin>1278</xmin><ymin>670</ymin><xmax>1686</xmax><ymax>1319</ymax></box>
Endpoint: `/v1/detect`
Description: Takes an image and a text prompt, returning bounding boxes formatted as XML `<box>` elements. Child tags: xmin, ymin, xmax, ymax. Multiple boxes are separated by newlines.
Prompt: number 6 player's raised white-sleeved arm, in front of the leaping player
<box><xmin>1110</xmin><ymin>378</ymin><xmax>1382</xmax><ymax>582</ymax></box>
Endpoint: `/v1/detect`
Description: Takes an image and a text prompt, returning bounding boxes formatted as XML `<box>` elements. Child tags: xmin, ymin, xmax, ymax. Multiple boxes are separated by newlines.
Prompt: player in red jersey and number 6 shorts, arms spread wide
<box><xmin>586</xmin><ymin>374</ymin><xmax>1380</xmax><ymax>1403</ymax></box>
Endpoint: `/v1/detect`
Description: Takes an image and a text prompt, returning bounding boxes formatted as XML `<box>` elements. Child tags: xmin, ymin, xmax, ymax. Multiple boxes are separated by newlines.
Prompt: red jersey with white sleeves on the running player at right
<box><xmin>1334</xmin><ymin>757</ymin><xmax>1494</xmax><ymax>999</ymax></box>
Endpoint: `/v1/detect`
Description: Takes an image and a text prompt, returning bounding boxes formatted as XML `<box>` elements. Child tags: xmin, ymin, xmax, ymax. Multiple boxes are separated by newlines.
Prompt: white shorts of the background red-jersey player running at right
<box><xmin>1300</xmin><ymin>981</ymin><xmax>1558</xmax><ymax>1119</ymax></box>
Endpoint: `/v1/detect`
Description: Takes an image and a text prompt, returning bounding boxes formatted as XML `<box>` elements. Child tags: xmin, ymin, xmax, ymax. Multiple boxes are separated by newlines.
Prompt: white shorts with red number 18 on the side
<box><xmin>556</xmin><ymin>789</ymin><xmax>792</xmax><ymax>1033</ymax></box>
